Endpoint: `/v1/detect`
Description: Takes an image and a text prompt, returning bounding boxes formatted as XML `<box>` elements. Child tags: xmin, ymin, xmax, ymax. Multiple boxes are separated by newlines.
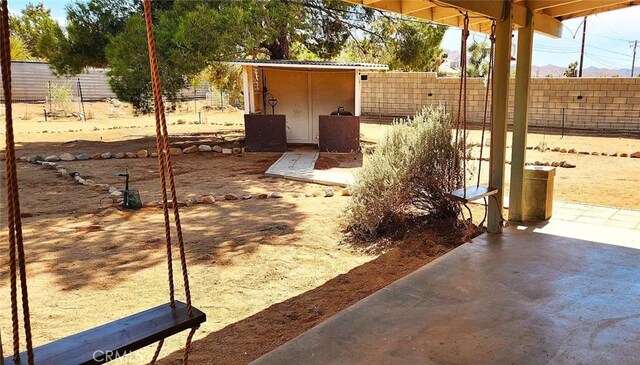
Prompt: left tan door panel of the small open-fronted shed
<box><xmin>265</xmin><ymin>68</ymin><xmax>313</xmax><ymax>143</ymax></box>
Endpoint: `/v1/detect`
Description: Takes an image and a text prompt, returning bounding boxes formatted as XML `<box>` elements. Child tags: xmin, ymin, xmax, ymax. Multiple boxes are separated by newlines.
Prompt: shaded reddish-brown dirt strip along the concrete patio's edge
<box><xmin>159</xmin><ymin>221</ymin><xmax>464</xmax><ymax>364</ymax></box>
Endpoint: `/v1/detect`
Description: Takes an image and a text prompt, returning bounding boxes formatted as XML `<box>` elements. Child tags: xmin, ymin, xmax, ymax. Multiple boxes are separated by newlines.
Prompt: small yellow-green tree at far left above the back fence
<box><xmin>9</xmin><ymin>3</ymin><xmax>62</xmax><ymax>60</ymax></box>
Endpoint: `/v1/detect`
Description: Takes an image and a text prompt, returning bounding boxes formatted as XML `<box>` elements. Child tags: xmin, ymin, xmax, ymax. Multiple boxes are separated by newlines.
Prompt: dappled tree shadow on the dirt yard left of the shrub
<box><xmin>0</xmin><ymin>138</ymin><xmax>305</xmax><ymax>291</ymax></box>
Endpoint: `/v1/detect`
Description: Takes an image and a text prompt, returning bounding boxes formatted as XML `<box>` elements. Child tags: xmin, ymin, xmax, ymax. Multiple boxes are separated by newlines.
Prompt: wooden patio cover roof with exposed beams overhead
<box><xmin>344</xmin><ymin>0</ymin><xmax>640</xmax><ymax>38</ymax></box>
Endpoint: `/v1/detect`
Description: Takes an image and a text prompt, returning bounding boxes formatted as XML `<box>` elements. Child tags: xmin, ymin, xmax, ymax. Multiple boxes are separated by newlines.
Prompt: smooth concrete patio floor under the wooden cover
<box><xmin>255</xmin><ymin>220</ymin><xmax>640</xmax><ymax>364</ymax></box>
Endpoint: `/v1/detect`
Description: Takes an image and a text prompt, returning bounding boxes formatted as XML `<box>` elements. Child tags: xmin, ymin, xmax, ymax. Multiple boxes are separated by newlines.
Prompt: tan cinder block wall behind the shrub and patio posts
<box><xmin>362</xmin><ymin>72</ymin><xmax>640</xmax><ymax>131</ymax></box>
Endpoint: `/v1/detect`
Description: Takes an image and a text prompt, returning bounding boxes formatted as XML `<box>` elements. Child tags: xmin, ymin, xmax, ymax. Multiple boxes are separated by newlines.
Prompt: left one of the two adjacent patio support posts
<box><xmin>487</xmin><ymin>1</ymin><xmax>513</xmax><ymax>233</ymax></box>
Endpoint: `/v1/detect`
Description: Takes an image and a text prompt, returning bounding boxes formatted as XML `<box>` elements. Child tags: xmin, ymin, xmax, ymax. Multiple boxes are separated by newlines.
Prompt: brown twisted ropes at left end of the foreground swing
<box><xmin>0</xmin><ymin>0</ymin><xmax>34</xmax><ymax>365</ymax></box>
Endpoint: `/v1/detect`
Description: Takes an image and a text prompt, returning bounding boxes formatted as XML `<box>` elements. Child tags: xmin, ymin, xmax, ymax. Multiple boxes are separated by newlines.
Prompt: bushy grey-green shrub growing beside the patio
<box><xmin>348</xmin><ymin>107</ymin><xmax>460</xmax><ymax>239</ymax></box>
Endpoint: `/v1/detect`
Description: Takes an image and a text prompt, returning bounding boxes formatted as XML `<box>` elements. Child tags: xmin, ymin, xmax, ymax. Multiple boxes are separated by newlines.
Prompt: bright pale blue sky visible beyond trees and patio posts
<box><xmin>9</xmin><ymin>0</ymin><xmax>640</xmax><ymax>69</ymax></box>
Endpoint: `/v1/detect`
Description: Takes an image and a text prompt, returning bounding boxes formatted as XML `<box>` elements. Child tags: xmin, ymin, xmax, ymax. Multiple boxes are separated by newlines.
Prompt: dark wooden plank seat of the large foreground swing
<box><xmin>4</xmin><ymin>301</ymin><xmax>207</xmax><ymax>365</ymax></box>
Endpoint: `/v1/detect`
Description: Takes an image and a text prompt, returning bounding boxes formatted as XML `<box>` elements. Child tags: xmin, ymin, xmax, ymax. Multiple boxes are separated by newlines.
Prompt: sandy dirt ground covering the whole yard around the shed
<box><xmin>0</xmin><ymin>103</ymin><xmax>640</xmax><ymax>364</ymax></box>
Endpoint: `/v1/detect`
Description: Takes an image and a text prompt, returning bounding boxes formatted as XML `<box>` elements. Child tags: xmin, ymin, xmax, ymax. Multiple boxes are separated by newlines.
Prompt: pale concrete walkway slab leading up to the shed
<box><xmin>265</xmin><ymin>151</ymin><xmax>355</xmax><ymax>187</ymax></box>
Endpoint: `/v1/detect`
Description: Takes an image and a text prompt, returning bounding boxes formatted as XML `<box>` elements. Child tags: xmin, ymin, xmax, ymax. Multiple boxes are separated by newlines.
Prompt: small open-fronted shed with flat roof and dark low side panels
<box><xmin>232</xmin><ymin>59</ymin><xmax>388</xmax><ymax>152</ymax></box>
